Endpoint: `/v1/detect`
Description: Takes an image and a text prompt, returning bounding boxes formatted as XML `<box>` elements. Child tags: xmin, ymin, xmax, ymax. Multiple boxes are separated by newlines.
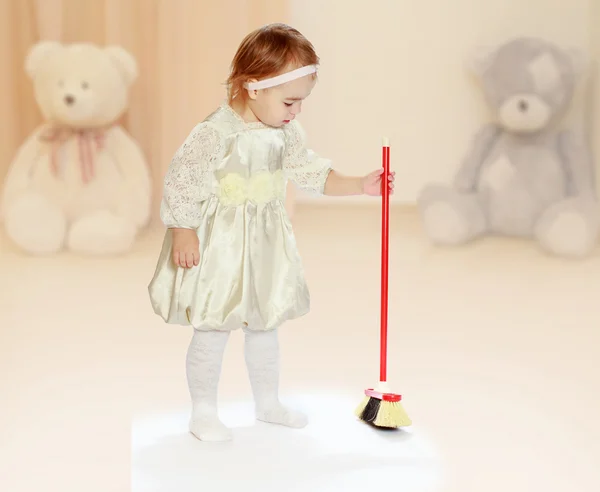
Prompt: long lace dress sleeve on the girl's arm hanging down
<box><xmin>160</xmin><ymin>122</ymin><xmax>223</xmax><ymax>229</ymax></box>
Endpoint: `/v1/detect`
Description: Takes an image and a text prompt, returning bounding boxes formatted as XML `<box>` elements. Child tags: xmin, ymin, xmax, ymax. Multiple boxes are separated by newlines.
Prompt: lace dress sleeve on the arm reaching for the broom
<box><xmin>283</xmin><ymin>121</ymin><xmax>332</xmax><ymax>195</ymax></box>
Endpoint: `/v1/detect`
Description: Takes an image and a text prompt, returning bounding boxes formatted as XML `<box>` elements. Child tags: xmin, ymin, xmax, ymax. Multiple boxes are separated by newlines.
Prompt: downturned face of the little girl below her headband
<box><xmin>248</xmin><ymin>74</ymin><xmax>317</xmax><ymax>128</ymax></box>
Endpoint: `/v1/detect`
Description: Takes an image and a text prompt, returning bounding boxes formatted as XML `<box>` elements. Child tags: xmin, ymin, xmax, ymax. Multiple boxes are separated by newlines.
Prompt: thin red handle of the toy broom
<box><xmin>379</xmin><ymin>138</ymin><xmax>390</xmax><ymax>382</ymax></box>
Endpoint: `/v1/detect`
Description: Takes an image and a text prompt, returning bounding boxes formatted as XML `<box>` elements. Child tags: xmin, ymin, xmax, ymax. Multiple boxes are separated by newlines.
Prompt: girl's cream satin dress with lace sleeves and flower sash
<box><xmin>148</xmin><ymin>103</ymin><xmax>331</xmax><ymax>331</ymax></box>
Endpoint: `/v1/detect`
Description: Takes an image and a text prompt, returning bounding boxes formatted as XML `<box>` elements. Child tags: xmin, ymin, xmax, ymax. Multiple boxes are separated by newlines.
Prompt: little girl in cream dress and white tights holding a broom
<box><xmin>149</xmin><ymin>24</ymin><xmax>394</xmax><ymax>441</ymax></box>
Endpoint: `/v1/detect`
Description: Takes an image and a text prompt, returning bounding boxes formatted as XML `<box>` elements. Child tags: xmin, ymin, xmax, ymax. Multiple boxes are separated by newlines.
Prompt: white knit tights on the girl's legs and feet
<box><xmin>186</xmin><ymin>329</ymin><xmax>307</xmax><ymax>441</ymax></box>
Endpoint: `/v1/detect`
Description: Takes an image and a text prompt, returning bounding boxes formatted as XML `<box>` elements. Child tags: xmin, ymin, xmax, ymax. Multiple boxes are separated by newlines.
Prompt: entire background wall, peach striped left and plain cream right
<box><xmin>0</xmin><ymin>0</ymin><xmax>600</xmax><ymax>215</ymax></box>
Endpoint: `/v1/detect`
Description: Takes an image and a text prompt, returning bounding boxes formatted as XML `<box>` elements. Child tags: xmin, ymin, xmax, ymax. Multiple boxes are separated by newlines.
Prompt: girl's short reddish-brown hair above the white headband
<box><xmin>227</xmin><ymin>23</ymin><xmax>319</xmax><ymax>103</ymax></box>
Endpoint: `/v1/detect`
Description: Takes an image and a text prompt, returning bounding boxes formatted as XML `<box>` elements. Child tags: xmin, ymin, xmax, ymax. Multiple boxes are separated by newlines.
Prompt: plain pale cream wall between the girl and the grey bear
<box><xmin>290</xmin><ymin>0</ymin><xmax>600</xmax><ymax>202</ymax></box>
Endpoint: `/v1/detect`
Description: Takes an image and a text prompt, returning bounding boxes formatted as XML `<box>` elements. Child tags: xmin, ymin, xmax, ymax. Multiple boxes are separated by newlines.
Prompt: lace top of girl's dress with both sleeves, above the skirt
<box><xmin>161</xmin><ymin>103</ymin><xmax>331</xmax><ymax>228</ymax></box>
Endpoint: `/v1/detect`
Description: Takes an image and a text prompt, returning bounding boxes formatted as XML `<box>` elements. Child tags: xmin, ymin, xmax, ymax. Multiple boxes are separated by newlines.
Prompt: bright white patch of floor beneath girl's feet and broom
<box><xmin>132</xmin><ymin>390</ymin><xmax>441</xmax><ymax>492</ymax></box>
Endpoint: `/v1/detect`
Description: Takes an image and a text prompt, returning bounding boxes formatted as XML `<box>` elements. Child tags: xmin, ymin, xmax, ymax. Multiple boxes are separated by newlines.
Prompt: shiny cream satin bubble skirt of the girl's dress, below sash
<box><xmin>148</xmin><ymin>197</ymin><xmax>310</xmax><ymax>331</ymax></box>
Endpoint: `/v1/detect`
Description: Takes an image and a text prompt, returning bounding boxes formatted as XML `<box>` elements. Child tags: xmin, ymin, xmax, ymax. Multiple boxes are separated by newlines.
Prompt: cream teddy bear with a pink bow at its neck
<box><xmin>0</xmin><ymin>41</ymin><xmax>152</xmax><ymax>255</ymax></box>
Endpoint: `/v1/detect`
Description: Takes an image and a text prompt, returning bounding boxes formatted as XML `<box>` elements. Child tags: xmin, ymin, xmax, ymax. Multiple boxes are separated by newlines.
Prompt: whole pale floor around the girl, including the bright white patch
<box><xmin>0</xmin><ymin>206</ymin><xmax>600</xmax><ymax>492</ymax></box>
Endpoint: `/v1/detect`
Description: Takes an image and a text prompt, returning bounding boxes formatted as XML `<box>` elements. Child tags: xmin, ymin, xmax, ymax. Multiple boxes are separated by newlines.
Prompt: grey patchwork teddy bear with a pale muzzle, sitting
<box><xmin>417</xmin><ymin>37</ymin><xmax>600</xmax><ymax>258</ymax></box>
